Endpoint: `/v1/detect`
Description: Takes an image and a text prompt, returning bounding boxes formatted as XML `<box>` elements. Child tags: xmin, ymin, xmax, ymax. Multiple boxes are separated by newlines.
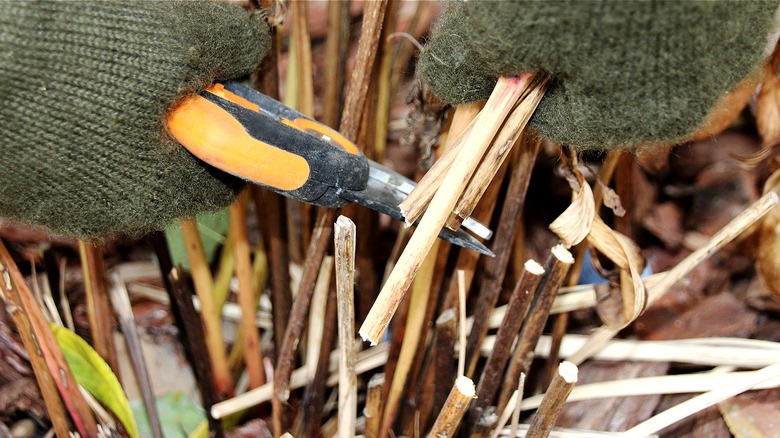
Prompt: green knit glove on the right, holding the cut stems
<box><xmin>419</xmin><ymin>0</ymin><xmax>778</xmax><ymax>149</ymax></box>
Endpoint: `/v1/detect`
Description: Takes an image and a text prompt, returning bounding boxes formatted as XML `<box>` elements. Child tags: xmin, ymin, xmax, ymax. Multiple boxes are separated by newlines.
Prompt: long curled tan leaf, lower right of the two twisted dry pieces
<box><xmin>588</xmin><ymin>217</ymin><xmax>647</xmax><ymax>326</ymax></box>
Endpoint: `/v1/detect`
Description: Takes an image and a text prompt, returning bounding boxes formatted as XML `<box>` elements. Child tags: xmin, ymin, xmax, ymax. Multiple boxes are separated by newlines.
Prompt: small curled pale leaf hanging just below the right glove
<box><xmin>550</xmin><ymin>167</ymin><xmax>596</xmax><ymax>248</ymax></box>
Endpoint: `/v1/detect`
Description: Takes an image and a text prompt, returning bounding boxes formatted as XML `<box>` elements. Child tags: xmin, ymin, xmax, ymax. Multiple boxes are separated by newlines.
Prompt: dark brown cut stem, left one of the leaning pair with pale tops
<box><xmin>468</xmin><ymin>260</ymin><xmax>544</xmax><ymax>427</ymax></box>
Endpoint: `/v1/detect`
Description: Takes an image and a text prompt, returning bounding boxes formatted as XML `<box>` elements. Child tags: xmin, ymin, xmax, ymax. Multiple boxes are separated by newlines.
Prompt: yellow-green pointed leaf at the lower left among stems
<box><xmin>51</xmin><ymin>324</ymin><xmax>139</xmax><ymax>438</ymax></box>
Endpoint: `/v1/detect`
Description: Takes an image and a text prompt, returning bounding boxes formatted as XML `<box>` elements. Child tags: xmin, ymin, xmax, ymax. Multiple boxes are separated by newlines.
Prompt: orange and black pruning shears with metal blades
<box><xmin>167</xmin><ymin>82</ymin><xmax>493</xmax><ymax>256</ymax></box>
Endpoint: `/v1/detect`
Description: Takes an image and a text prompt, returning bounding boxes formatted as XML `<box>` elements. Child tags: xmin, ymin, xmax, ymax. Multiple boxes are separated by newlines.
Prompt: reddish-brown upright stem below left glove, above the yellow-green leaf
<box><xmin>79</xmin><ymin>240</ymin><xmax>119</xmax><ymax>375</ymax></box>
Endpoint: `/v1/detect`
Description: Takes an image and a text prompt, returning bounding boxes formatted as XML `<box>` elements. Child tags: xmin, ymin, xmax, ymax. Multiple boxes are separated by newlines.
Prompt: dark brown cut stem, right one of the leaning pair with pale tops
<box><xmin>498</xmin><ymin>245</ymin><xmax>574</xmax><ymax>411</ymax></box>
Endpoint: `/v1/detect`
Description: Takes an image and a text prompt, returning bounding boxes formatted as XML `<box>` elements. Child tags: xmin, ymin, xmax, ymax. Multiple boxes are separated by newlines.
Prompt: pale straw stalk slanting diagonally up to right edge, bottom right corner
<box><xmin>623</xmin><ymin>363</ymin><xmax>780</xmax><ymax>438</ymax></box>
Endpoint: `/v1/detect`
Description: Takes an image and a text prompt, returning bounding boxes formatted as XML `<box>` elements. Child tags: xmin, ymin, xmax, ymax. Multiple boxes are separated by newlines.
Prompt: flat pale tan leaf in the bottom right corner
<box><xmin>718</xmin><ymin>396</ymin><xmax>780</xmax><ymax>438</ymax></box>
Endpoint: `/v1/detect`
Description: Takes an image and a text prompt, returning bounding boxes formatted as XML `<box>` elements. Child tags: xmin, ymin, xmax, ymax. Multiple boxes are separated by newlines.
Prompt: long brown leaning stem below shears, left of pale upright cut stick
<box><xmin>272</xmin><ymin>210</ymin><xmax>334</xmax><ymax>436</ymax></box>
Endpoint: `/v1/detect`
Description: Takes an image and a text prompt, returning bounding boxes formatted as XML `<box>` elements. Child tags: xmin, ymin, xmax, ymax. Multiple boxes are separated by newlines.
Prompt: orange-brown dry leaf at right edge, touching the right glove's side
<box><xmin>756</xmin><ymin>46</ymin><xmax>780</xmax><ymax>146</ymax></box>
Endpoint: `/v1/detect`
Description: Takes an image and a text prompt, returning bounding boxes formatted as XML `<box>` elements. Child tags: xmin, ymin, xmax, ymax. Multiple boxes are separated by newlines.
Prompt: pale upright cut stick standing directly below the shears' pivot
<box><xmin>334</xmin><ymin>216</ymin><xmax>357</xmax><ymax>438</ymax></box>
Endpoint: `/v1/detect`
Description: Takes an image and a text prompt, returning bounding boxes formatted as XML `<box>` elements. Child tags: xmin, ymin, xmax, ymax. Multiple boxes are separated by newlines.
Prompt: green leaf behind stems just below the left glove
<box><xmin>165</xmin><ymin>208</ymin><xmax>230</xmax><ymax>270</ymax></box>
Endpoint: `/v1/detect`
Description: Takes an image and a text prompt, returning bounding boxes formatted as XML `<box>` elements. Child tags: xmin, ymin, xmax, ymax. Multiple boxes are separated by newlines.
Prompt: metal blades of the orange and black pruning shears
<box><xmin>339</xmin><ymin>160</ymin><xmax>495</xmax><ymax>257</ymax></box>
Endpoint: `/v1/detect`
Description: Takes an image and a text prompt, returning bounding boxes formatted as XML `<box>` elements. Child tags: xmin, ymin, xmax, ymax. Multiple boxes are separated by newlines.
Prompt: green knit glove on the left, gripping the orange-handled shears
<box><xmin>0</xmin><ymin>0</ymin><xmax>270</xmax><ymax>237</ymax></box>
